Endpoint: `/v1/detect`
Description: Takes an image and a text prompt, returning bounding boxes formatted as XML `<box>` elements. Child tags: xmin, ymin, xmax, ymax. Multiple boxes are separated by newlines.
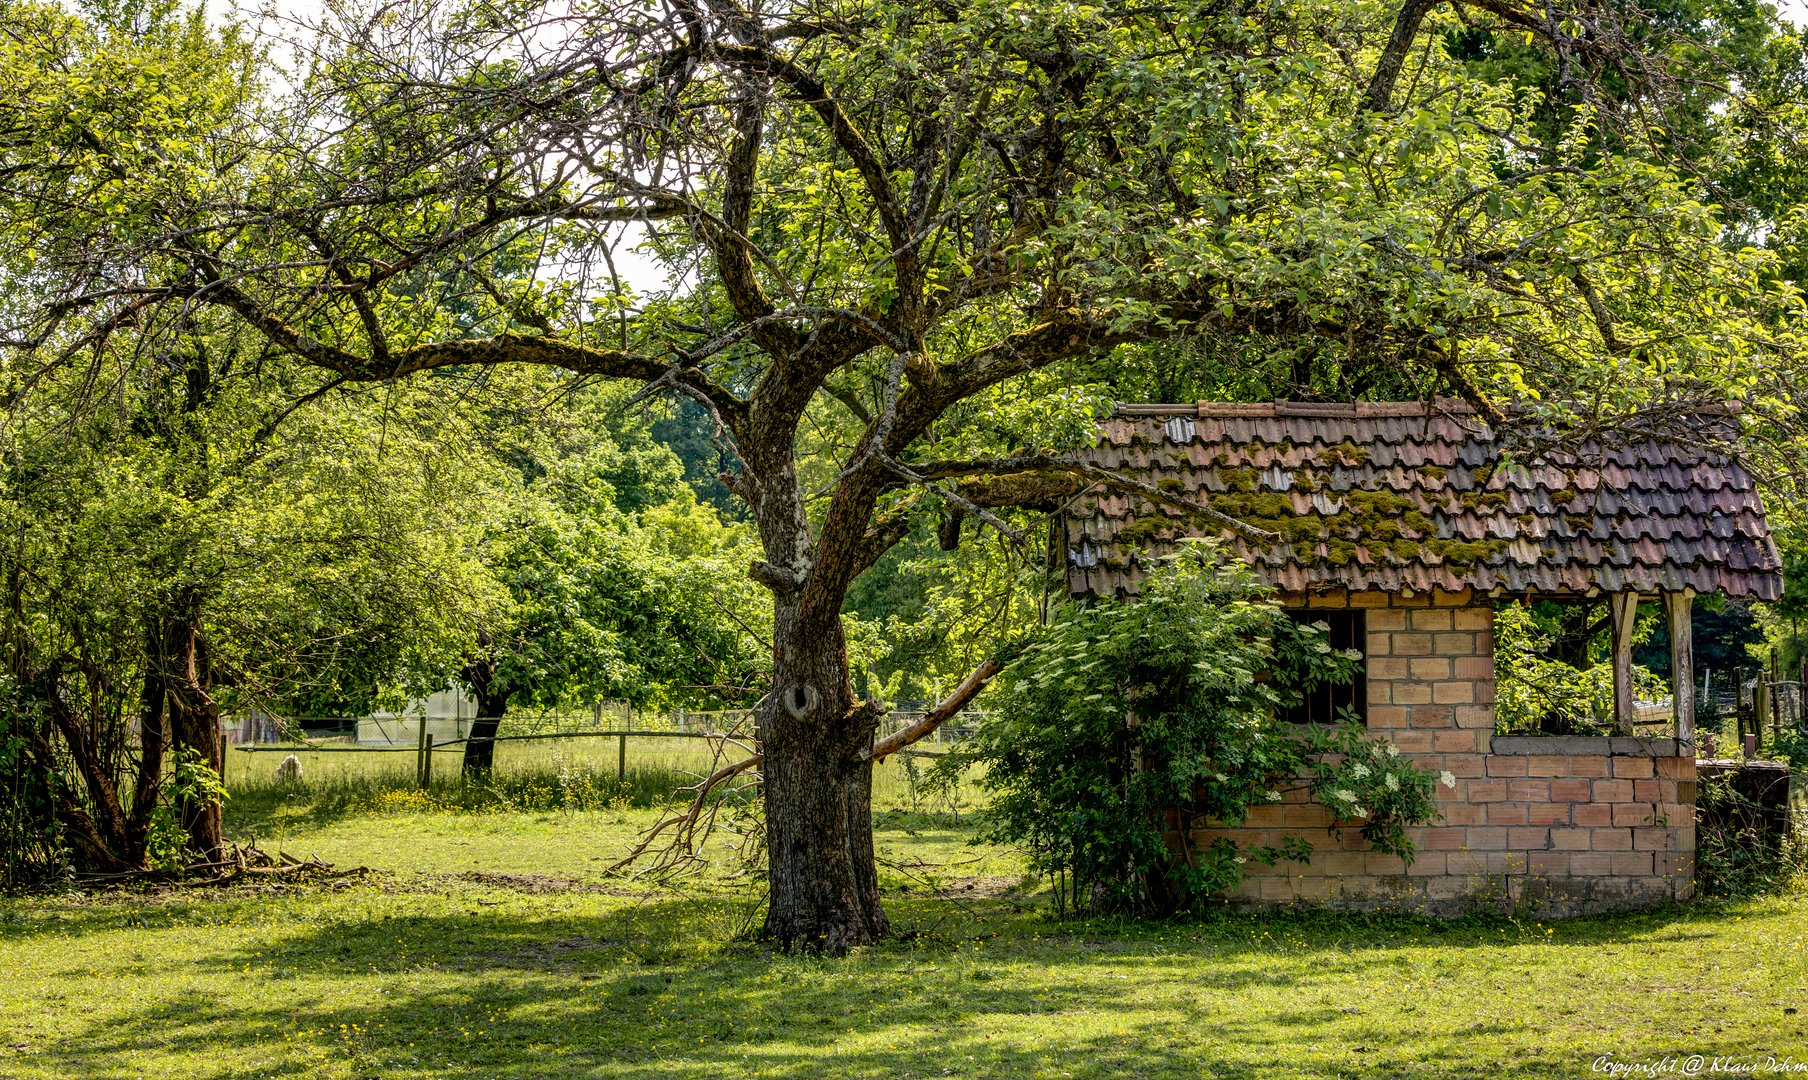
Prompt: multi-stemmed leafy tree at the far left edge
<box><xmin>0</xmin><ymin>338</ymin><xmax>506</xmax><ymax>870</ymax></box>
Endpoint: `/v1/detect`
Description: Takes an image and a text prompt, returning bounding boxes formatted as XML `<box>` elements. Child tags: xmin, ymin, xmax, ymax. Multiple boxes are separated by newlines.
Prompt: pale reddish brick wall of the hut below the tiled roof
<box><xmin>1195</xmin><ymin>592</ymin><xmax>1696</xmax><ymax>915</ymax></box>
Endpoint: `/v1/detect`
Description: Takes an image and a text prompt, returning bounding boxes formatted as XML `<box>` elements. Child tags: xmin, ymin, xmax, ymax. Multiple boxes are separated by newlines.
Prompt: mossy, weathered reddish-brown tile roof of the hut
<box><xmin>1061</xmin><ymin>400</ymin><xmax>1783</xmax><ymax>601</ymax></box>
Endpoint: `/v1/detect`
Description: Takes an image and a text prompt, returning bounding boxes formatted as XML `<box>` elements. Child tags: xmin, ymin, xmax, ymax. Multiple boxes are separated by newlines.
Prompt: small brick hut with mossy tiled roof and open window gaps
<box><xmin>1056</xmin><ymin>400</ymin><xmax>1783</xmax><ymax>915</ymax></box>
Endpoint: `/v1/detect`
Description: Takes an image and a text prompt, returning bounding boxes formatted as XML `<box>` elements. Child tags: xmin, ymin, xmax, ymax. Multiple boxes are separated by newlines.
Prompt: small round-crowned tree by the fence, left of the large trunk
<box><xmin>459</xmin><ymin>389</ymin><xmax>767</xmax><ymax>774</ymax></box>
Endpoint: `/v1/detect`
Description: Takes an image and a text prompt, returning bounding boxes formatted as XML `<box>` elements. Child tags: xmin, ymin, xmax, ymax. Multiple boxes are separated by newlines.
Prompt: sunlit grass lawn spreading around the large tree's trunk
<box><xmin>0</xmin><ymin>763</ymin><xmax>1808</xmax><ymax>1078</ymax></box>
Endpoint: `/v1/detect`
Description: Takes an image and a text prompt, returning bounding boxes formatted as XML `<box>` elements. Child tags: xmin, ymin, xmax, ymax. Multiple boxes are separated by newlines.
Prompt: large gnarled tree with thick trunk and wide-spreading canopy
<box><xmin>0</xmin><ymin>0</ymin><xmax>1797</xmax><ymax>948</ymax></box>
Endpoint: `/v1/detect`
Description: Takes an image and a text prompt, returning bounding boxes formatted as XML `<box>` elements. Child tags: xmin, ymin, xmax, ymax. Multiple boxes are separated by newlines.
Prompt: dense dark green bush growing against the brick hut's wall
<box><xmin>946</xmin><ymin>541</ymin><xmax>1436</xmax><ymax>910</ymax></box>
